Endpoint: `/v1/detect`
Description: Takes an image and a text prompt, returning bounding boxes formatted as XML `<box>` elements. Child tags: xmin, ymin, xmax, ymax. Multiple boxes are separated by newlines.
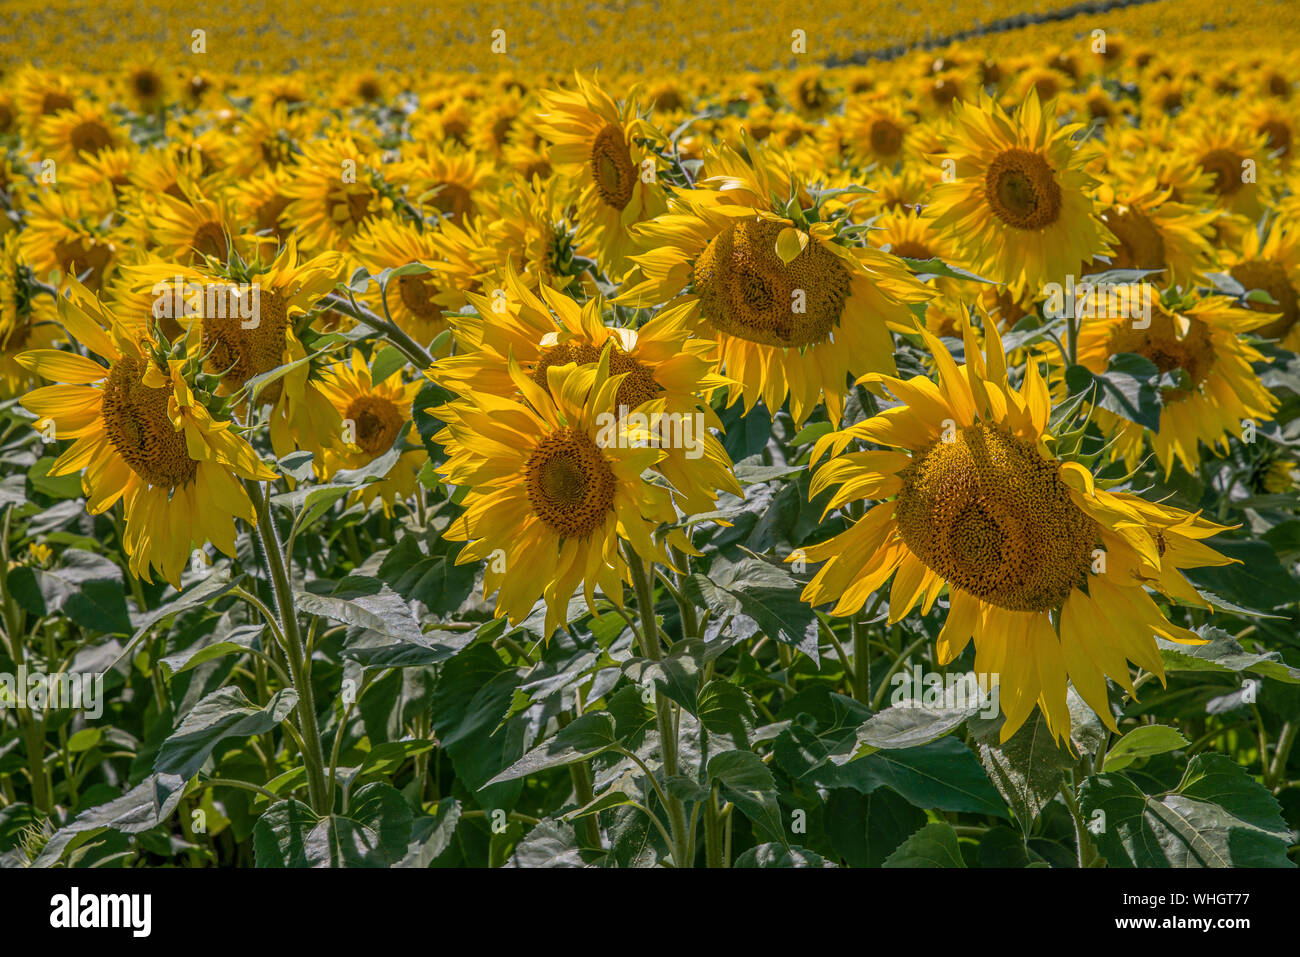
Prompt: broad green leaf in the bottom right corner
<box><xmin>1079</xmin><ymin>754</ymin><xmax>1295</xmax><ymax>867</ymax></box>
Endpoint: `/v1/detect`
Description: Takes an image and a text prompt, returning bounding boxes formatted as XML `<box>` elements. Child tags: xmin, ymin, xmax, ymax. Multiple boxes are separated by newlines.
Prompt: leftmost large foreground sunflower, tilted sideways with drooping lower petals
<box><xmin>20</xmin><ymin>281</ymin><xmax>276</xmax><ymax>589</ymax></box>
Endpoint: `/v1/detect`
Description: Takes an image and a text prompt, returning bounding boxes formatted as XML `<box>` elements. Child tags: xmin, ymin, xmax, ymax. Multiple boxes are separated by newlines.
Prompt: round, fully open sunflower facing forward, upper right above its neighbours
<box><xmin>928</xmin><ymin>91</ymin><xmax>1114</xmax><ymax>294</ymax></box>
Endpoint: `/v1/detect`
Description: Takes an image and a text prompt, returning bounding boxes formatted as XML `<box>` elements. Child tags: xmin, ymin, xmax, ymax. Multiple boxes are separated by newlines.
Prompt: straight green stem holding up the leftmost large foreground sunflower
<box><xmin>244</xmin><ymin>479</ymin><xmax>330</xmax><ymax>815</ymax></box>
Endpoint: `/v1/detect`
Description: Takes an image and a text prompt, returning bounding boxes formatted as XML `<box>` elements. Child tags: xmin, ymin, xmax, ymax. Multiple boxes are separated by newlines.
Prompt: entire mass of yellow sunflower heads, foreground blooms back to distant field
<box><xmin>0</xmin><ymin>38</ymin><xmax>1300</xmax><ymax>740</ymax></box>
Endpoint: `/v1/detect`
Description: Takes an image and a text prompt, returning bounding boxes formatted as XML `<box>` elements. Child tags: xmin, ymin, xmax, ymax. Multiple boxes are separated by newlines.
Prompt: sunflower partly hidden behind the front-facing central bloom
<box><xmin>429</xmin><ymin>265</ymin><xmax>742</xmax><ymax>514</ymax></box>
